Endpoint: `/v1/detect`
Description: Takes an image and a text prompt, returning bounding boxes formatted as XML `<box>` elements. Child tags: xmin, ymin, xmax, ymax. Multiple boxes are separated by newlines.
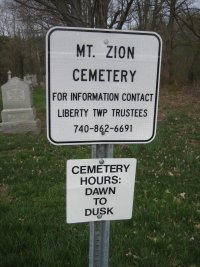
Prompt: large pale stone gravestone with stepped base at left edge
<box><xmin>0</xmin><ymin>73</ymin><xmax>40</xmax><ymax>133</ymax></box>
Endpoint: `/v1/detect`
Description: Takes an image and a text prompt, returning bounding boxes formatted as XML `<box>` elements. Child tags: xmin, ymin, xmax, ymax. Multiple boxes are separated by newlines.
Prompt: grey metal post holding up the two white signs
<box><xmin>89</xmin><ymin>145</ymin><xmax>113</xmax><ymax>267</ymax></box>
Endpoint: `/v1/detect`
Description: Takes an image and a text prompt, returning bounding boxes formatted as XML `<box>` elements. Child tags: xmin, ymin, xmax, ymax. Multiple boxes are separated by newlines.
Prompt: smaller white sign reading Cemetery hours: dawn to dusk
<box><xmin>67</xmin><ymin>158</ymin><xmax>136</xmax><ymax>223</ymax></box>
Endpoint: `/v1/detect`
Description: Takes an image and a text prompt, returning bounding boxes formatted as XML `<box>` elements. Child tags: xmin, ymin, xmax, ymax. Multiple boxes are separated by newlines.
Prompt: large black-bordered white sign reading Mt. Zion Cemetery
<box><xmin>46</xmin><ymin>27</ymin><xmax>162</xmax><ymax>145</ymax></box>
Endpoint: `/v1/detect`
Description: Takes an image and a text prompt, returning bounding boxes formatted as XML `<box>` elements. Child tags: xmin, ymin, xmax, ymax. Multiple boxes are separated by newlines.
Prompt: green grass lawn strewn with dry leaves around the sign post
<box><xmin>0</xmin><ymin>88</ymin><xmax>200</xmax><ymax>267</ymax></box>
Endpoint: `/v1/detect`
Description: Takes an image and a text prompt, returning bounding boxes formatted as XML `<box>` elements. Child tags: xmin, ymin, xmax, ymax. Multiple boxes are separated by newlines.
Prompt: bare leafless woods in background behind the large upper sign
<box><xmin>0</xmin><ymin>0</ymin><xmax>200</xmax><ymax>84</ymax></box>
